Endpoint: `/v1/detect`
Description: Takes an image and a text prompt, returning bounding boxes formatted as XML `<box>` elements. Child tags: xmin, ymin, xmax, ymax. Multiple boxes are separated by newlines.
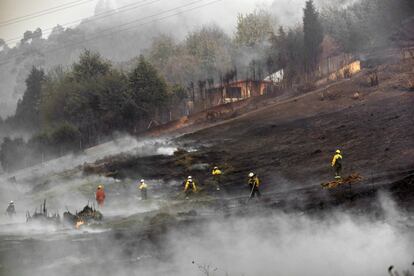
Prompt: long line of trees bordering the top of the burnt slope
<box><xmin>0</xmin><ymin>0</ymin><xmax>414</xmax><ymax>170</ymax></box>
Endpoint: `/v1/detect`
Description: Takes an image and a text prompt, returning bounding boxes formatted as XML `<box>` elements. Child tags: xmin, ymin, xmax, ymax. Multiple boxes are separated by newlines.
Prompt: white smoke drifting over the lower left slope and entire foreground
<box><xmin>0</xmin><ymin>135</ymin><xmax>414</xmax><ymax>276</ymax></box>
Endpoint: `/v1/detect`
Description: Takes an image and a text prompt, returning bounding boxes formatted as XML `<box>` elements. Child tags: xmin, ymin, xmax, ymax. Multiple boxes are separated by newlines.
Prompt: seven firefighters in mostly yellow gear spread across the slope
<box><xmin>6</xmin><ymin>150</ymin><xmax>342</xmax><ymax>216</ymax></box>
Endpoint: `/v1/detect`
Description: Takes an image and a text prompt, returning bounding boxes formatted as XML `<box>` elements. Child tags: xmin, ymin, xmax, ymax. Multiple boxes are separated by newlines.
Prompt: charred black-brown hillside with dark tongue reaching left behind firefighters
<box><xmin>85</xmin><ymin>50</ymin><xmax>414</xmax><ymax>210</ymax></box>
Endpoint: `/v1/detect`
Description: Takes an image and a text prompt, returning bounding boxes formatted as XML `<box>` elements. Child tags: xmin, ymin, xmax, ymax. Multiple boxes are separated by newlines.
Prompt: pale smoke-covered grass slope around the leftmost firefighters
<box><xmin>0</xmin><ymin>136</ymin><xmax>180</xmax><ymax>229</ymax></box>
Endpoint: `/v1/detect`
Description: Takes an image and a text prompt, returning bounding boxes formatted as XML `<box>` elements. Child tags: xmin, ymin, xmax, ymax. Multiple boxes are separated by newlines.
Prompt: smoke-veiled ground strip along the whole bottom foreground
<box><xmin>0</xmin><ymin>192</ymin><xmax>414</xmax><ymax>276</ymax></box>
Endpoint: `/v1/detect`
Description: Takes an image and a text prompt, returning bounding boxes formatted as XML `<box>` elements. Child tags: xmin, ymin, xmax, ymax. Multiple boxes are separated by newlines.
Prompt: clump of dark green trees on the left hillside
<box><xmin>0</xmin><ymin>50</ymin><xmax>186</xmax><ymax>170</ymax></box>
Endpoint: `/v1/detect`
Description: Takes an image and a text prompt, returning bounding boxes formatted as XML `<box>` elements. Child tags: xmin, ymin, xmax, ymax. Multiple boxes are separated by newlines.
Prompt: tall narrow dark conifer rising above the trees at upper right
<box><xmin>303</xmin><ymin>0</ymin><xmax>323</xmax><ymax>73</ymax></box>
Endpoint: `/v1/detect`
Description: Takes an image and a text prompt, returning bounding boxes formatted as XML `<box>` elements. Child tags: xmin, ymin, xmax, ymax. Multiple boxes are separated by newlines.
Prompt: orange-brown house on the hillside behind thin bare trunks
<box><xmin>206</xmin><ymin>80</ymin><xmax>278</xmax><ymax>106</ymax></box>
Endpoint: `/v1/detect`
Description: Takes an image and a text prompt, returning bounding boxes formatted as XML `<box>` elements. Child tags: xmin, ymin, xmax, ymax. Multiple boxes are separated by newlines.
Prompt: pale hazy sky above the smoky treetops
<box><xmin>0</xmin><ymin>0</ymin><xmax>357</xmax><ymax>45</ymax></box>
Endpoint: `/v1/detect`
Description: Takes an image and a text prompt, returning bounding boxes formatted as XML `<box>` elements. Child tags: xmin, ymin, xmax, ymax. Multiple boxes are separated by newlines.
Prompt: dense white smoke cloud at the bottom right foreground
<box><xmin>168</xmin><ymin>209</ymin><xmax>414</xmax><ymax>275</ymax></box>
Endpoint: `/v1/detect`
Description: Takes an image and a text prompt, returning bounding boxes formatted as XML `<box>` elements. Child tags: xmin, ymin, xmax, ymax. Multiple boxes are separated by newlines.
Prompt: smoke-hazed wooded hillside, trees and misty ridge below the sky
<box><xmin>0</xmin><ymin>0</ymin><xmax>414</xmax><ymax>168</ymax></box>
